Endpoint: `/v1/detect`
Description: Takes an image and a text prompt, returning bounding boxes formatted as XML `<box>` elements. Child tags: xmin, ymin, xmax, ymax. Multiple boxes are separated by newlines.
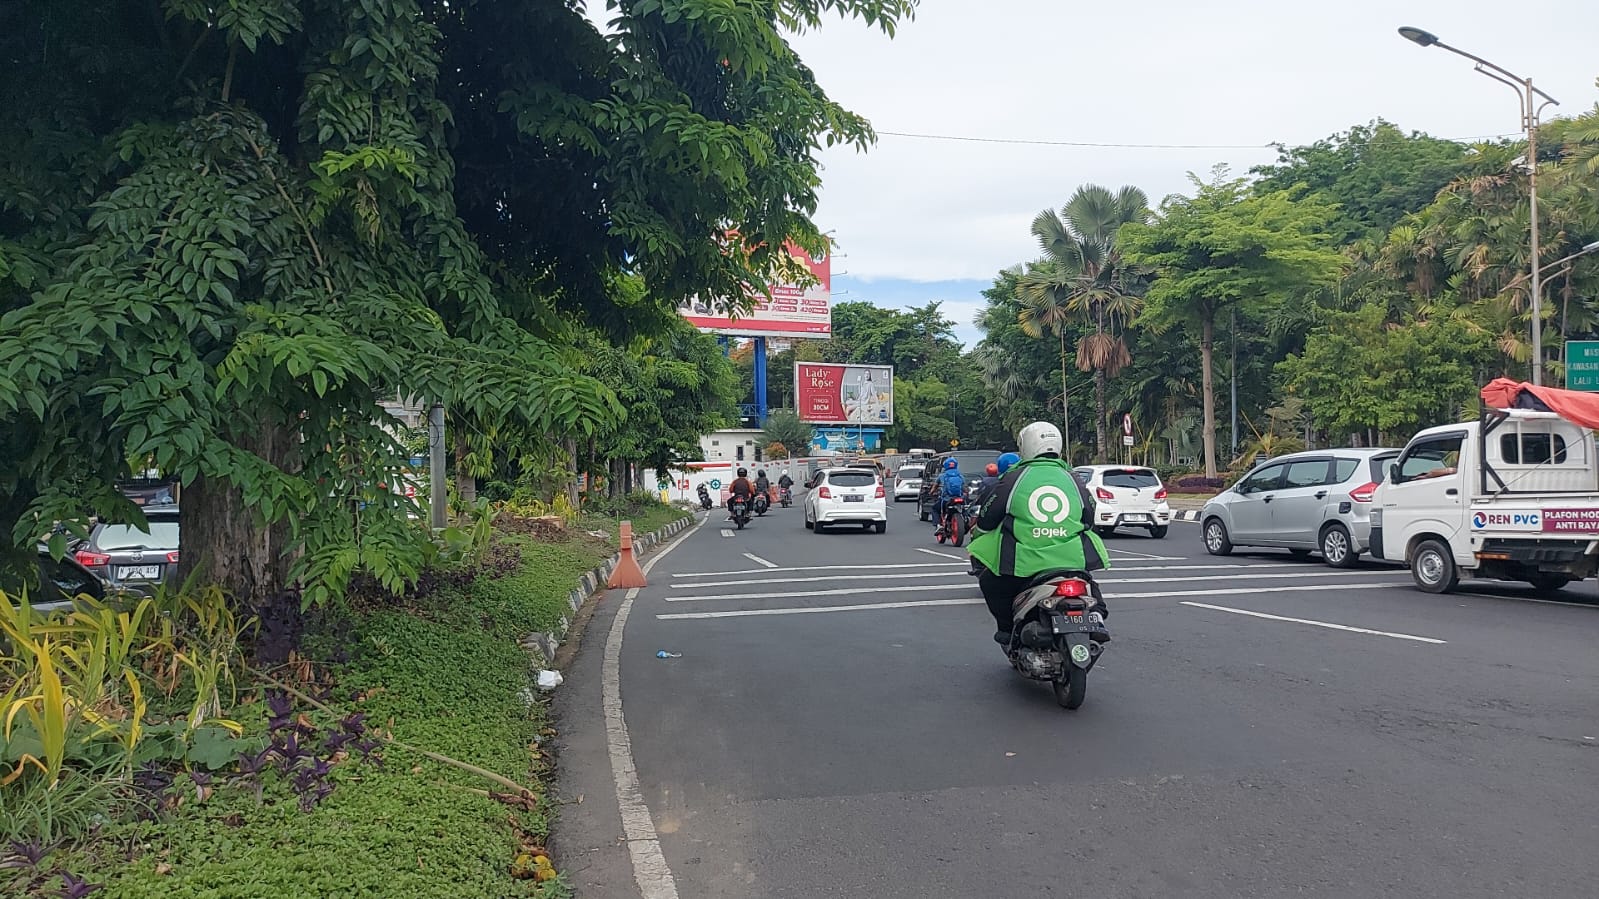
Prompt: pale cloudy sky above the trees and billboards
<box><xmin>793</xmin><ymin>0</ymin><xmax>1599</xmax><ymax>346</ymax></box>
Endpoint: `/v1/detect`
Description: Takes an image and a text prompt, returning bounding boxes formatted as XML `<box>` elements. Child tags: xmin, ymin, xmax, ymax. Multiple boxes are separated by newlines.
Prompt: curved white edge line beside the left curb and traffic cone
<box><xmin>600</xmin><ymin>517</ymin><xmax>703</xmax><ymax>899</ymax></box>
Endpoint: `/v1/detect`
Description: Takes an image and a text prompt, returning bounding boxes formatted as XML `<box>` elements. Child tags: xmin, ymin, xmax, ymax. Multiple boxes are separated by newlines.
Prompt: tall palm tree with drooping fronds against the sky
<box><xmin>1017</xmin><ymin>184</ymin><xmax>1150</xmax><ymax>461</ymax></box>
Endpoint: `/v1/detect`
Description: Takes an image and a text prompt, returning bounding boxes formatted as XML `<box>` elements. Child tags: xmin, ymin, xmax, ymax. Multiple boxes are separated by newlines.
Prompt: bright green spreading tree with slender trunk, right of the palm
<box><xmin>1119</xmin><ymin>168</ymin><xmax>1343</xmax><ymax>477</ymax></box>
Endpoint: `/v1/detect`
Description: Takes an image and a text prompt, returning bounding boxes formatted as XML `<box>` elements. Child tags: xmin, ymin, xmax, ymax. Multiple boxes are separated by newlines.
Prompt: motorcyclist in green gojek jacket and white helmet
<box><xmin>971</xmin><ymin>421</ymin><xmax>1110</xmax><ymax>643</ymax></box>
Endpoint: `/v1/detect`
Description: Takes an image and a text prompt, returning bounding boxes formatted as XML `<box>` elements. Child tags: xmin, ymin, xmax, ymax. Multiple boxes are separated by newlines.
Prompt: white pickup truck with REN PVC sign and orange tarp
<box><xmin>1372</xmin><ymin>402</ymin><xmax>1599</xmax><ymax>593</ymax></box>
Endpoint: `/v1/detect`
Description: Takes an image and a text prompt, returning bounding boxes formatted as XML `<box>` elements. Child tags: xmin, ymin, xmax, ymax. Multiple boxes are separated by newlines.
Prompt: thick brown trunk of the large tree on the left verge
<box><xmin>177</xmin><ymin>414</ymin><xmax>301</xmax><ymax>614</ymax></box>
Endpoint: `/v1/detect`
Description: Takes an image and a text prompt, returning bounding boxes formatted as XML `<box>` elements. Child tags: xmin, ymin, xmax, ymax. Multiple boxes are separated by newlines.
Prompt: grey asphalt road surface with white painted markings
<box><xmin>555</xmin><ymin>504</ymin><xmax>1599</xmax><ymax>899</ymax></box>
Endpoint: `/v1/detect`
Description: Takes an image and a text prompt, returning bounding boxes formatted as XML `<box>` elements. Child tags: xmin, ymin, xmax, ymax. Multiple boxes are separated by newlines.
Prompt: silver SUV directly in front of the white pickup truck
<box><xmin>1199</xmin><ymin>450</ymin><xmax>1399</xmax><ymax>568</ymax></box>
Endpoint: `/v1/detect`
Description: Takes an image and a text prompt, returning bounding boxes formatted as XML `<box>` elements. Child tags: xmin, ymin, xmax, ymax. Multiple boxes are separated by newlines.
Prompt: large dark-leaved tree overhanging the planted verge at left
<box><xmin>0</xmin><ymin>0</ymin><xmax>915</xmax><ymax>605</ymax></box>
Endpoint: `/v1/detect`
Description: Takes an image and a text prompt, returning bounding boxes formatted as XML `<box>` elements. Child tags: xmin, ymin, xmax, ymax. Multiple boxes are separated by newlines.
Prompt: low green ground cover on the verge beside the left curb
<box><xmin>19</xmin><ymin>492</ymin><xmax>686</xmax><ymax>899</ymax></box>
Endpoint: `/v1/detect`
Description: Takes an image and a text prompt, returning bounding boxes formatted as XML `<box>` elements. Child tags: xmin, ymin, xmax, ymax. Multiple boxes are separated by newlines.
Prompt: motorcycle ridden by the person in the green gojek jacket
<box><xmin>996</xmin><ymin>571</ymin><xmax>1110</xmax><ymax>709</ymax></box>
